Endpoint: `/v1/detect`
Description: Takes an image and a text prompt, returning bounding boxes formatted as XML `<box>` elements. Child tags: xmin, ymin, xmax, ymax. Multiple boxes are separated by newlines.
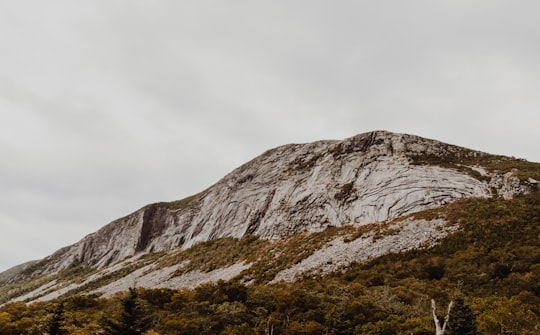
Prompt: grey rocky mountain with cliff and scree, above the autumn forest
<box><xmin>0</xmin><ymin>131</ymin><xmax>540</xmax><ymax>301</ymax></box>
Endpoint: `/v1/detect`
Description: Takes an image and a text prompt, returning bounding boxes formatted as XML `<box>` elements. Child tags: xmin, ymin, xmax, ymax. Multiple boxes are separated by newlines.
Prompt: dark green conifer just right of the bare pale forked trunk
<box><xmin>444</xmin><ymin>290</ymin><xmax>478</xmax><ymax>335</ymax></box>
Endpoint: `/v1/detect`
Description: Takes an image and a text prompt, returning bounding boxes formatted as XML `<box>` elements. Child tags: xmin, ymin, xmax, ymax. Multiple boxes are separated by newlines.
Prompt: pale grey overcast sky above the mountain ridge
<box><xmin>0</xmin><ymin>0</ymin><xmax>540</xmax><ymax>271</ymax></box>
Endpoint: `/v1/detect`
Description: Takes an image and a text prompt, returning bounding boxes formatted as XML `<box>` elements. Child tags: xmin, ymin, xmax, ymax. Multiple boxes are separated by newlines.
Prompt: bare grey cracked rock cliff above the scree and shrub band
<box><xmin>32</xmin><ymin>131</ymin><xmax>526</xmax><ymax>273</ymax></box>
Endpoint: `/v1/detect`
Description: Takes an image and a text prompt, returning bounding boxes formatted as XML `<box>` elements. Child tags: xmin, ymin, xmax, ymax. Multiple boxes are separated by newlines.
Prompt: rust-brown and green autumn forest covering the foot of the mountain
<box><xmin>0</xmin><ymin>193</ymin><xmax>540</xmax><ymax>335</ymax></box>
